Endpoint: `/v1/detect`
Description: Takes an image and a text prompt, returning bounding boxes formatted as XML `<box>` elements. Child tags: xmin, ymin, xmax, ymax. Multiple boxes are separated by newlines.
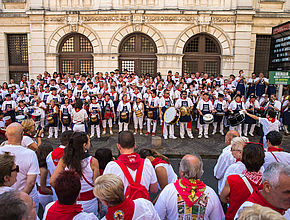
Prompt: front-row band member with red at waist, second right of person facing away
<box><xmin>102</xmin><ymin>92</ymin><xmax>117</xmax><ymax>135</ymax></box>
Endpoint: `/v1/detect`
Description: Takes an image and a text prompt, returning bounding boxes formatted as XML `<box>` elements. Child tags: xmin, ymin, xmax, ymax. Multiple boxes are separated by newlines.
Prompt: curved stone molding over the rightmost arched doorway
<box><xmin>173</xmin><ymin>25</ymin><xmax>233</xmax><ymax>56</ymax></box>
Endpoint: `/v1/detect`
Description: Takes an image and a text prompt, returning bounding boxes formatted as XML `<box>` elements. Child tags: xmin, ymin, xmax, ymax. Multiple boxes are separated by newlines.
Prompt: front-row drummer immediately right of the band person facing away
<box><xmin>89</xmin><ymin>97</ymin><xmax>101</xmax><ymax>138</ymax></box>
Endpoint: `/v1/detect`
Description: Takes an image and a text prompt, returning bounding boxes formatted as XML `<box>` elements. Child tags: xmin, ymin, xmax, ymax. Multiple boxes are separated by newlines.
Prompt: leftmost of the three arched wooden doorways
<box><xmin>59</xmin><ymin>33</ymin><xmax>94</xmax><ymax>74</ymax></box>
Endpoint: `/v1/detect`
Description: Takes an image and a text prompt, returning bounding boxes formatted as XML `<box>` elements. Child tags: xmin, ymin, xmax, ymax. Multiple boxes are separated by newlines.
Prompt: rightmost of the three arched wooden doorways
<box><xmin>182</xmin><ymin>34</ymin><xmax>221</xmax><ymax>74</ymax></box>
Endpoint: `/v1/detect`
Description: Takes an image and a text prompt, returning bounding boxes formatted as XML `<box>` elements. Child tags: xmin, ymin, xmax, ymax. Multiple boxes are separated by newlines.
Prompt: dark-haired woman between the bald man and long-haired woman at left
<box><xmin>36</xmin><ymin>145</ymin><xmax>53</xmax><ymax>209</ymax></box>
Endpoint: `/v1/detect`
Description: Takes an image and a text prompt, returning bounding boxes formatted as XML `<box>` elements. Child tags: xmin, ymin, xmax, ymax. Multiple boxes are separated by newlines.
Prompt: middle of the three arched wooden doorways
<box><xmin>119</xmin><ymin>32</ymin><xmax>157</xmax><ymax>76</ymax></box>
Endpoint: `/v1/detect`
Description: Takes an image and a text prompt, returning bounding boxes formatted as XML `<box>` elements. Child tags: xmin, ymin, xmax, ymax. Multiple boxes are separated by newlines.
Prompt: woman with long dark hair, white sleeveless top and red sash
<box><xmin>49</xmin><ymin>132</ymin><xmax>99</xmax><ymax>214</ymax></box>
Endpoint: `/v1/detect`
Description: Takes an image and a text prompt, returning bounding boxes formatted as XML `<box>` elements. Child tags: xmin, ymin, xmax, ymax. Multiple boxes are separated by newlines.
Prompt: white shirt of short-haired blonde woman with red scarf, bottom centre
<box><xmin>102</xmin><ymin>198</ymin><xmax>160</xmax><ymax>220</ymax></box>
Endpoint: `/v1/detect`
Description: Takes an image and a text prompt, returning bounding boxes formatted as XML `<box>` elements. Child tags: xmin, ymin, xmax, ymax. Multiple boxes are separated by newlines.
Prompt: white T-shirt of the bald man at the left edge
<box><xmin>0</xmin><ymin>144</ymin><xmax>40</xmax><ymax>201</ymax></box>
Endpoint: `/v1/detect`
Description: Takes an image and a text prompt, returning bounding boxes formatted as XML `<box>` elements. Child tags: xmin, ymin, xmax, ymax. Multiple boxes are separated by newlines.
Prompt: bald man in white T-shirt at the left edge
<box><xmin>0</xmin><ymin>122</ymin><xmax>40</xmax><ymax>211</ymax></box>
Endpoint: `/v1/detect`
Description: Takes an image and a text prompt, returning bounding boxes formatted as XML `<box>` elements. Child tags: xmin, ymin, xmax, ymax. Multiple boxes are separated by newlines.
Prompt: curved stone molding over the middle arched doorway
<box><xmin>108</xmin><ymin>24</ymin><xmax>167</xmax><ymax>54</ymax></box>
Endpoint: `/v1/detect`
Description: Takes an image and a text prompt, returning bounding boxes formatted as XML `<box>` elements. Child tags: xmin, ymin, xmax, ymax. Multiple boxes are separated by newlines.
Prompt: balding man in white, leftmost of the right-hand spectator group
<box><xmin>214</xmin><ymin>130</ymin><xmax>240</xmax><ymax>193</ymax></box>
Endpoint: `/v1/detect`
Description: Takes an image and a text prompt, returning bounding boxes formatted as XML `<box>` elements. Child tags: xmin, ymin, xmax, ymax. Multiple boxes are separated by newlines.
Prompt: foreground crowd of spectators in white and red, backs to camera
<box><xmin>0</xmin><ymin>122</ymin><xmax>290</xmax><ymax>220</ymax></box>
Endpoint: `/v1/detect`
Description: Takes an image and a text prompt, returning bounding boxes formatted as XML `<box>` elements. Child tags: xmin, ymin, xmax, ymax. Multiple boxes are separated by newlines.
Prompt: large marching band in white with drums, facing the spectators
<box><xmin>0</xmin><ymin>69</ymin><xmax>290</xmax><ymax>139</ymax></box>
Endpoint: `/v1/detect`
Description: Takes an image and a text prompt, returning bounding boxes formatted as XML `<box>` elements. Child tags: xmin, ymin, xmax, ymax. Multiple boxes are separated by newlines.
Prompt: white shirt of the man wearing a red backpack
<box><xmin>104</xmin><ymin>159</ymin><xmax>157</xmax><ymax>190</ymax></box>
